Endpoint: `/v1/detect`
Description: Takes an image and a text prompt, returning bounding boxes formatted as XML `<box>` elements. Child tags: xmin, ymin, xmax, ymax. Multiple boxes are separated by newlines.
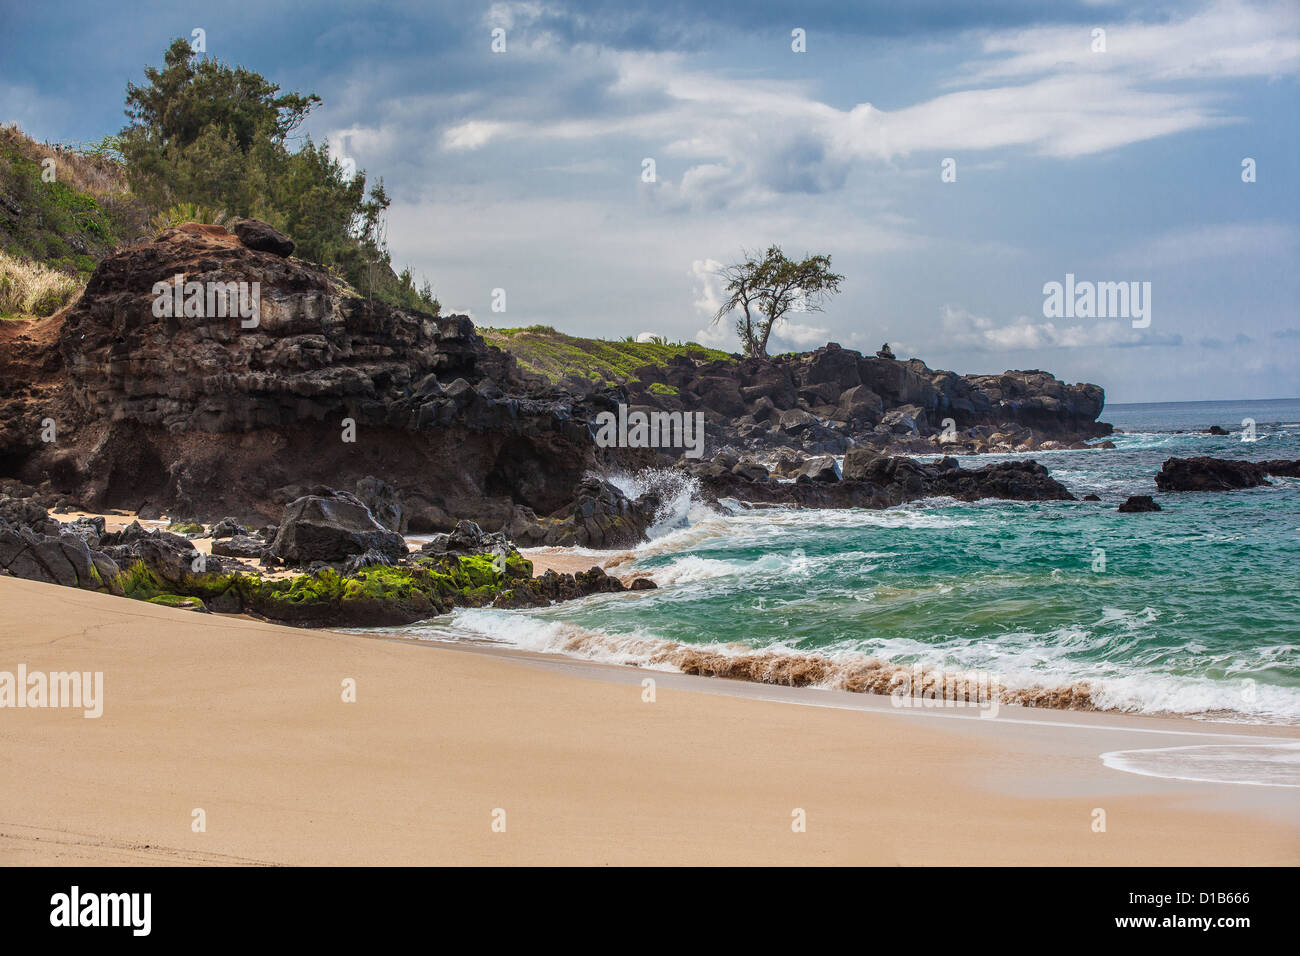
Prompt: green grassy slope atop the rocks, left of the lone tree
<box><xmin>478</xmin><ymin>325</ymin><xmax>731</xmax><ymax>388</ymax></box>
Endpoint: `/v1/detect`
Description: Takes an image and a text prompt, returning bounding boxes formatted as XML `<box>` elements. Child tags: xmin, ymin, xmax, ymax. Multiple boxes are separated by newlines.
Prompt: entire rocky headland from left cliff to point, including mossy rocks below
<box><xmin>0</xmin><ymin>215</ymin><xmax>1110</xmax><ymax>623</ymax></box>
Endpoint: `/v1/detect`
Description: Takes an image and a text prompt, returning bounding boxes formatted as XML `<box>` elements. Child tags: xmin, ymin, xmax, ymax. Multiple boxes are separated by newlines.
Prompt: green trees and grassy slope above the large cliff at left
<box><xmin>0</xmin><ymin>39</ymin><xmax>439</xmax><ymax>317</ymax></box>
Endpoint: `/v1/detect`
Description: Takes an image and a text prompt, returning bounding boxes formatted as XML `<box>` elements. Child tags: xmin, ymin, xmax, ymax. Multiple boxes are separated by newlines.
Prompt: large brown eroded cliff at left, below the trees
<box><xmin>0</xmin><ymin>224</ymin><xmax>597</xmax><ymax>532</ymax></box>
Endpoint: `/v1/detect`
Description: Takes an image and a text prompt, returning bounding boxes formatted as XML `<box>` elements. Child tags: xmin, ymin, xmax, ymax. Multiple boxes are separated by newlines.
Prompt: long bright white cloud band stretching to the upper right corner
<box><xmin>421</xmin><ymin>0</ymin><xmax>1300</xmax><ymax>208</ymax></box>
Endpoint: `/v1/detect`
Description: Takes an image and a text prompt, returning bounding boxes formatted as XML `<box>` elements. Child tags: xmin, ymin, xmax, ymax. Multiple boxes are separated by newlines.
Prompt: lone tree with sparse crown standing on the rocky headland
<box><xmin>712</xmin><ymin>246</ymin><xmax>844</xmax><ymax>359</ymax></box>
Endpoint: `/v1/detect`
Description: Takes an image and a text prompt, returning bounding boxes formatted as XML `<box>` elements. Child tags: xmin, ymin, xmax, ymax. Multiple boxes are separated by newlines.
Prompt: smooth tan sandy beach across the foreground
<box><xmin>0</xmin><ymin>578</ymin><xmax>1300</xmax><ymax>865</ymax></box>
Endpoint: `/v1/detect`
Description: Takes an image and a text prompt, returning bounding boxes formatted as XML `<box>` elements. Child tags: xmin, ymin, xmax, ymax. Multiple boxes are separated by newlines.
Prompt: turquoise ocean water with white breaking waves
<box><xmin>377</xmin><ymin>399</ymin><xmax>1300</xmax><ymax>723</ymax></box>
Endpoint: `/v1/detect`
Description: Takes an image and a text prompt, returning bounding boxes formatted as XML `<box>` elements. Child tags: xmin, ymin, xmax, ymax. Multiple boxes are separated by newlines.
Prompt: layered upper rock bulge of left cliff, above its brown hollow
<box><xmin>60</xmin><ymin>226</ymin><xmax>484</xmax><ymax>432</ymax></box>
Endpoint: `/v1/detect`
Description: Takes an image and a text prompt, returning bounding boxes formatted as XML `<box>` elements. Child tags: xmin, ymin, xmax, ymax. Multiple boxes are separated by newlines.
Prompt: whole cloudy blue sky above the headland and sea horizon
<box><xmin>0</xmin><ymin>0</ymin><xmax>1300</xmax><ymax>402</ymax></box>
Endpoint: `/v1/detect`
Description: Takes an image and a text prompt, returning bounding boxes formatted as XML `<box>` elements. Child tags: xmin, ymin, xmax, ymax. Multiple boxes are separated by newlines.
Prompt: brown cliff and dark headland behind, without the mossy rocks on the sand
<box><xmin>0</xmin><ymin>221</ymin><xmax>1109</xmax><ymax>548</ymax></box>
